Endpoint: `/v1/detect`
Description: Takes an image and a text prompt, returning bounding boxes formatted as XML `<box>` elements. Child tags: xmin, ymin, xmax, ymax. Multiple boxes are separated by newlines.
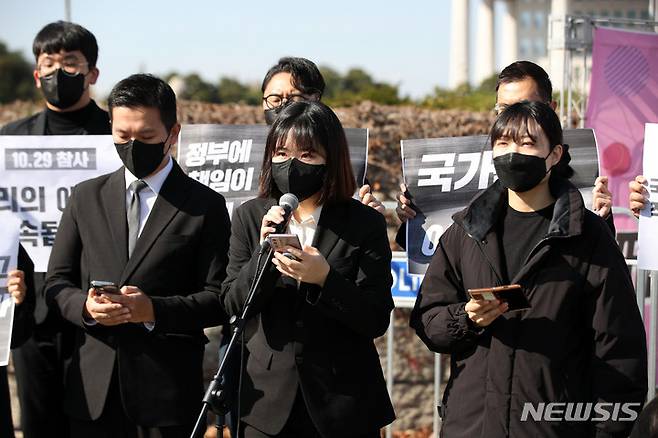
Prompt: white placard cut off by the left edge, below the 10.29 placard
<box><xmin>0</xmin><ymin>212</ymin><xmax>20</xmax><ymax>366</ymax></box>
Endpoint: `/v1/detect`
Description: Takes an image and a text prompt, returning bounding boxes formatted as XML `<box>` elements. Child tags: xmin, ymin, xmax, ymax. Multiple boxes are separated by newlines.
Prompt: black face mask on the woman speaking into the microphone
<box><xmin>272</xmin><ymin>158</ymin><xmax>327</xmax><ymax>201</ymax></box>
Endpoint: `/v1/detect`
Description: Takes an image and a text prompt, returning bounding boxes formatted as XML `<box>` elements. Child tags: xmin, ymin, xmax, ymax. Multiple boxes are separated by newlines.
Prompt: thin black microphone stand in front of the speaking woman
<box><xmin>190</xmin><ymin>246</ymin><xmax>274</xmax><ymax>438</ymax></box>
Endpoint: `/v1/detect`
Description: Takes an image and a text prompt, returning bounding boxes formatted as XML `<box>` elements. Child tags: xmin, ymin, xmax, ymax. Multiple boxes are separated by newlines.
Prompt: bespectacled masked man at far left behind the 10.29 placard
<box><xmin>0</xmin><ymin>21</ymin><xmax>111</xmax><ymax>438</ymax></box>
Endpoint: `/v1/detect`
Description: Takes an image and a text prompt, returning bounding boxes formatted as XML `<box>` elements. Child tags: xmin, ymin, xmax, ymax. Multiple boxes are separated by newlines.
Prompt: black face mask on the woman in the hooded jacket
<box><xmin>493</xmin><ymin>152</ymin><xmax>550</xmax><ymax>193</ymax></box>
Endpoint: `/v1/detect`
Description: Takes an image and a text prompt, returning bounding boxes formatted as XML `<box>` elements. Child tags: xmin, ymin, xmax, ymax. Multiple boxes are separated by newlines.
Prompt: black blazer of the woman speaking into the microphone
<box><xmin>222</xmin><ymin>198</ymin><xmax>395</xmax><ymax>437</ymax></box>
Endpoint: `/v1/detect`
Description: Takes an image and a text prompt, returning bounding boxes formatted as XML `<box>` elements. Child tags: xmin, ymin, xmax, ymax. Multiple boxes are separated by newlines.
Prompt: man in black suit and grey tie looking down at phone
<box><xmin>46</xmin><ymin>74</ymin><xmax>230</xmax><ymax>438</ymax></box>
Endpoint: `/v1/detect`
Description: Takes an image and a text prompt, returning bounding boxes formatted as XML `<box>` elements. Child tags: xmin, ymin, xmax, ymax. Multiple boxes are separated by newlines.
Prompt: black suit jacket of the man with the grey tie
<box><xmin>46</xmin><ymin>163</ymin><xmax>230</xmax><ymax>427</ymax></box>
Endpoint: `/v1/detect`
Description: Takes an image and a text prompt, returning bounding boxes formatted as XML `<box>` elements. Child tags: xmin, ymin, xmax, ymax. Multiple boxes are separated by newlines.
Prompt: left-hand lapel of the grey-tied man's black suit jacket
<box><xmin>101</xmin><ymin>167</ymin><xmax>128</xmax><ymax>266</ymax></box>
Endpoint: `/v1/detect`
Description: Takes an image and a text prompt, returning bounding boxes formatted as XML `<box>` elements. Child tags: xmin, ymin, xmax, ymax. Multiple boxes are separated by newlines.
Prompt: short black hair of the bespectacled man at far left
<box><xmin>32</xmin><ymin>21</ymin><xmax>98</xmax><ymax>68</ymax></box>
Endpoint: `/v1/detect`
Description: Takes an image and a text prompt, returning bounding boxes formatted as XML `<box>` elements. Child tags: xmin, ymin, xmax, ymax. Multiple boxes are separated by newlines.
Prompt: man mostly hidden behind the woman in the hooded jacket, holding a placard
<box><xmin>395</xmin><ymin>61</ymin><xmax>615</xmax><ymax>248</ymax></box>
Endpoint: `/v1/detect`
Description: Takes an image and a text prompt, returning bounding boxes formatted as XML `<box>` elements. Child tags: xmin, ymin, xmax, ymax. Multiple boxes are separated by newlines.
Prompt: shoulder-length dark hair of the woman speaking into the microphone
<box><xmin>258</xmin><ymin>102</ymin><xmax>356</xmax><ymax>204</ymax></box>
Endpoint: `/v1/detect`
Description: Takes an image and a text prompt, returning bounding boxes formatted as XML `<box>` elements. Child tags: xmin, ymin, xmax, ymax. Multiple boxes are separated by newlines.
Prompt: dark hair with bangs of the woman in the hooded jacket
<box><xmin>489</xmin><ymin>100</ymin><xmax>574</xmax><ymax>179</ymax></box>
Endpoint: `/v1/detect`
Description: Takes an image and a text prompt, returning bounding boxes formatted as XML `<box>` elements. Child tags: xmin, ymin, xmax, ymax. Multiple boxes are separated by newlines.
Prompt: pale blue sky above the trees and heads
<box><xmin>0</xmin><ymin>0</ymin><xmax>508</xmax><ymax>97</ymax></box>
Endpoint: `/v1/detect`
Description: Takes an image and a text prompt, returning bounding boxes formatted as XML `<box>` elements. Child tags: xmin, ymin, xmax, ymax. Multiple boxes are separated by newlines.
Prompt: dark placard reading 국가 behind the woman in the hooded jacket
<box><xmin>401</xmin><ymin>129</ymin><xmax>598</xmax><ymax>275</ymax></box>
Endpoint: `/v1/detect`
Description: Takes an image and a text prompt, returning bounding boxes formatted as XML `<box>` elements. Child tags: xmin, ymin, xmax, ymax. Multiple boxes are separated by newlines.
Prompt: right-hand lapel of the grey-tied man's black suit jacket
<box><xmin>121</xmin><ymin>162</ymin><xmax>190</xmax><ymax>283</ymax></box>
